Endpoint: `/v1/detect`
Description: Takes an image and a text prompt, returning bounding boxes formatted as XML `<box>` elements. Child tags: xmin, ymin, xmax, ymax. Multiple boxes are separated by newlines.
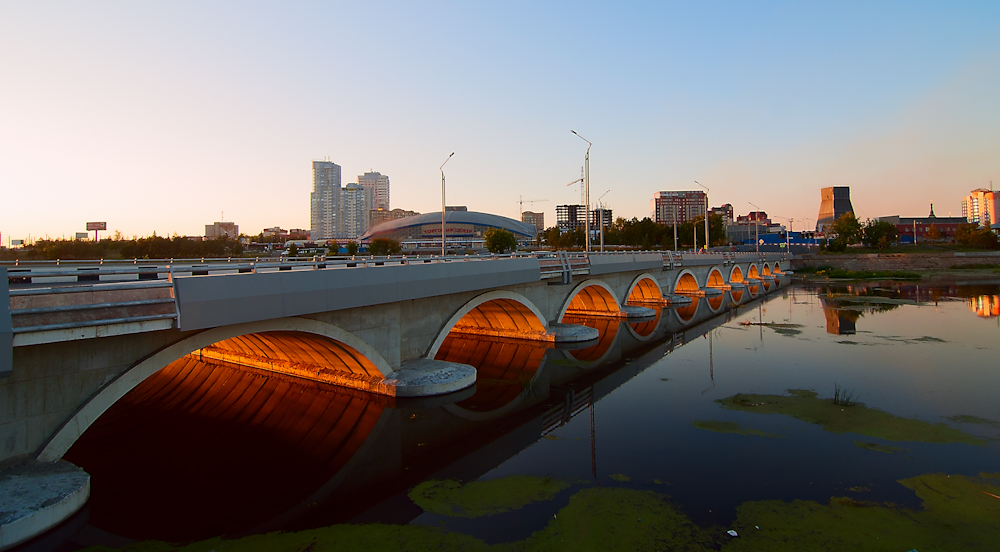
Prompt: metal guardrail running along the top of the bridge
<box><xmin>0</xmin><ymin>251</ymin><xmax>786</xmax><ymax>335</ymax></box>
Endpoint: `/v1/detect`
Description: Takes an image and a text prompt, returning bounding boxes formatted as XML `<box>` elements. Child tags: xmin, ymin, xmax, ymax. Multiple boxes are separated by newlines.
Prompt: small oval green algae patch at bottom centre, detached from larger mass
<box><xmin>409</xmin><ymin>475</ymin><xmax>570</xmax><ymax>518</ymax></box>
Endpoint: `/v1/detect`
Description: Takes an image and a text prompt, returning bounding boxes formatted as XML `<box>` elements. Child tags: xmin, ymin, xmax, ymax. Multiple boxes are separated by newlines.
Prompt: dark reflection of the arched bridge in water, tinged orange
<box><xmin>66</xmin><ymin>274</ymin><xmax>792</xmax><ymax>542</ymax></box>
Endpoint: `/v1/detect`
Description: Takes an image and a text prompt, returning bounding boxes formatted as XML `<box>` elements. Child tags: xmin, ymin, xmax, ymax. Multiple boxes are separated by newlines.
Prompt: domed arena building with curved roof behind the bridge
<box><xmin>358</xmin><ymin>211</ymin><xmax>537</xmax><ymax>252</ymax></box>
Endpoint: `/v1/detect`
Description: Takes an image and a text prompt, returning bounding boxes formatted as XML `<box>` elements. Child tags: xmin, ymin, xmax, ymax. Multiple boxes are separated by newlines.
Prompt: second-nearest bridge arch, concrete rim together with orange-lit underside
<box><xmin>426</xmin><ymin>290</ymin><xmax>550</xmax><ymax>358</ymax></box>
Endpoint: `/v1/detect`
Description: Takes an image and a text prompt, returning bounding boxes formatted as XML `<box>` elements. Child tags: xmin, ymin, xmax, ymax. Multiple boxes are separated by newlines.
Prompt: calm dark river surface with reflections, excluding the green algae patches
<box><xmin>58</xmin><ymin>283</ymin><xmax>1000</xmax><ymax>543</ymax></box>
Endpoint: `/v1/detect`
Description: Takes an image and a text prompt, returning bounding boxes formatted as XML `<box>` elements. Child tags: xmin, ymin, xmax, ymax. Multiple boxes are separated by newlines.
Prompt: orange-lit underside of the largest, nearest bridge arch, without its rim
<box><xmin>187</xmin><ymin>331</ymin><xmax>394</xmax><ymax>395</ymax></box>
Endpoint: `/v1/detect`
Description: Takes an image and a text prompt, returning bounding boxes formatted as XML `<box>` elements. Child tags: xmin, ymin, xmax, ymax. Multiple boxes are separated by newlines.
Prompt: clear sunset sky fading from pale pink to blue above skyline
<box><xmin>0</xmin><ymin>0</ymin><xmax>1000</xmax><ymax>244</ymax></box>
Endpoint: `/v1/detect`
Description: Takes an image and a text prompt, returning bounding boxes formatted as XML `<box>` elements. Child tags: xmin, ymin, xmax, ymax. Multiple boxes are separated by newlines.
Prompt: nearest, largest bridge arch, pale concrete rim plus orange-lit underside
<box><xmin>37</xmin><ymin>317</ymin><xmax>395</xmax><ymax>462</ymax></box>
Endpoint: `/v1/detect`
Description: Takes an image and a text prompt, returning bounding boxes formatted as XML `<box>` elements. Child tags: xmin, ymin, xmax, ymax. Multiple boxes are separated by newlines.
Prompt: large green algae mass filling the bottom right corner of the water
<box><xmin>723</xmin><ymin>473</ymin><xmax>1000</xmax><ymax>552</ymax></box>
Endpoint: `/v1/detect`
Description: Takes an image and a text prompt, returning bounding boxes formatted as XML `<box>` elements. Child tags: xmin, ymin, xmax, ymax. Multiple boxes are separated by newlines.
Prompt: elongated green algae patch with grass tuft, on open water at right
<box><xmin>715</xmin><ymin>389</ymin><xmax>986</xmax><ymax>445</ymax></box>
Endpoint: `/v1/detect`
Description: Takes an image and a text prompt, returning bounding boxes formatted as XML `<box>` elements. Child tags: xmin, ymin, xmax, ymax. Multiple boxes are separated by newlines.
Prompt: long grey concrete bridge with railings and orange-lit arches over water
<box><xmin>0</xmin><ymin>252</ymin><xmax>788</xmax><ymax>548</ymax></box>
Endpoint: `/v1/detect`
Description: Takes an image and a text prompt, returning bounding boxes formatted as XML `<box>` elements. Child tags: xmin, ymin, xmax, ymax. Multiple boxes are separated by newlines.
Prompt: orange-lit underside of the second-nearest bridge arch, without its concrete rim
<box><xmin>449</xmin><ymin>299</ymin><xmax>555</xmax><ymax>341</ymax></box>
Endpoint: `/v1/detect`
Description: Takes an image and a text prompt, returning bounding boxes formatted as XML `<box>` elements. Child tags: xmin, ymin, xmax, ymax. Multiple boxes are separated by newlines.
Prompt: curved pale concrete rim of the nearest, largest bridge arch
<box><xmin>37</xmin><ymin>317</ymin><xmax>394</xmax><ymax>462</ymax></box>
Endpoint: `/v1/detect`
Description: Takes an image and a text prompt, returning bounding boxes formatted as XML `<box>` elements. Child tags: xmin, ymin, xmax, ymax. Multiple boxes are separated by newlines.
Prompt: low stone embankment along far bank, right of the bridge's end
<box><xmin>791</xmin><ymin>251</ymin><xmax>1000</xmax><ymax>271</ymax></box>
